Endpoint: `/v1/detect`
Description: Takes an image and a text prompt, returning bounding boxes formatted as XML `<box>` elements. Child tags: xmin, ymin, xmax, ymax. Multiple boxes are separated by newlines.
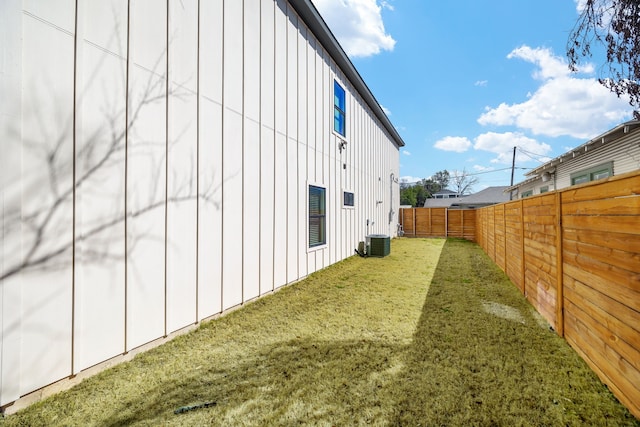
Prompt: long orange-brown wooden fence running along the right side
<box><xmin>476</xmin><ymin>172</ymin><xmax>640</xmax><ymax>418</ymax></box>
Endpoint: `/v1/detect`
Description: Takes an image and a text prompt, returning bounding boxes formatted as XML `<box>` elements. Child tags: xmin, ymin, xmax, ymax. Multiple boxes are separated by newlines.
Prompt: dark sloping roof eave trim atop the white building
<box><xmin>289</xmin><ymin>0</ymin><xmax>404</xmax><ymax>147</ymax></box>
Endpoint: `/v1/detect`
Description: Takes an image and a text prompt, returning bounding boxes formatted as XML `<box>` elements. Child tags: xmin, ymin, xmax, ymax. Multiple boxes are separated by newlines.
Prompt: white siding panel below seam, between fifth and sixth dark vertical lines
<box><xmin>222</xmin><ymin>109</ymin><xmax>243</xmax><ymax>309</ymax></box>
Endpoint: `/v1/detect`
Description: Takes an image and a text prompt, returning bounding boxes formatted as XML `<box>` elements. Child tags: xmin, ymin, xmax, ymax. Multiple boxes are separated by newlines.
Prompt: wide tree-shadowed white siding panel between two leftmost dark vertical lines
<box><xmin>74</xmin><ymin>0</ymin><xmax>127</xmax><ymax>372</ymax></box>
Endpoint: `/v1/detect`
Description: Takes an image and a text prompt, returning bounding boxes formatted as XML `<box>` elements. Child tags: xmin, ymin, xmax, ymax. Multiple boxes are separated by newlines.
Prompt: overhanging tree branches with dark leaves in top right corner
<box><xmin>567</xmin><ymin>0</ymin><xmax>640</xmax><ymax>119</ymax></box>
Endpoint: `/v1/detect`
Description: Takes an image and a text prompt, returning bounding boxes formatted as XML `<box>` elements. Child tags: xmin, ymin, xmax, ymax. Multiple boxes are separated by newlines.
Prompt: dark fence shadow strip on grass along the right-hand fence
<box><xmin>393</xmin><ymin>239</ymin><xmax>640</xmax><ymax>426</ymax></box>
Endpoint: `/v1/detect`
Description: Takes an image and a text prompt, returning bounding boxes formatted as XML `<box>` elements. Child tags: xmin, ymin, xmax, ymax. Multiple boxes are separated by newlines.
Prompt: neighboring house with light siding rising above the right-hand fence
<box><xmin>506</xmin><ymin>120</ymin><xmax>640</xmax><ymax>199</ymax></box>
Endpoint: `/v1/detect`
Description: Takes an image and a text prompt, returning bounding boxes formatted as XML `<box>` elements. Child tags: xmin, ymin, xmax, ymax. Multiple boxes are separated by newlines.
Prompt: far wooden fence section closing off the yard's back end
<box><xmin>399</xmin><ymin>208</ymin><xmax>476</xmax><ymax>241</ymax></box>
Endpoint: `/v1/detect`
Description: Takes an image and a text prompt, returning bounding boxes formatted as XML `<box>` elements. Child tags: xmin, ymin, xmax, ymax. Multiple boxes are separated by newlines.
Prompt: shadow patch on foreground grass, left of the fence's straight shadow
<box><xmin>105</xmin><ymin>339</ymin><xmax>402</xmax><ymax>426</ymax></box>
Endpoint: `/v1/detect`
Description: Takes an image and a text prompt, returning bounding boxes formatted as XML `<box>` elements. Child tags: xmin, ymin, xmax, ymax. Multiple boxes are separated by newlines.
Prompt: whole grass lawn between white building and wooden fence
<box><xmin>0</xmin><ymin>239</ymin><xmax>640</xmax><ymax>426</ymax></box>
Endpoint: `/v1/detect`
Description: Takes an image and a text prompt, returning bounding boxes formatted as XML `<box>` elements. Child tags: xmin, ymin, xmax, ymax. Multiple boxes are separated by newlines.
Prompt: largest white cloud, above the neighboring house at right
<box><xmin>478</xmin><ymin>46</ymin><xmax>632</xmax><ymax>139</ymax></box>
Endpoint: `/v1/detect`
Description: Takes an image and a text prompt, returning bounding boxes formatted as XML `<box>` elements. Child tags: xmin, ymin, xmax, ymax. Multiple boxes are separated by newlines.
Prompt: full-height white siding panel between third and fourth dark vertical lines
<box><xmin>166</xmin><ymin>0</ymin><xmax>198</xmax><ymax>332</ymax></box>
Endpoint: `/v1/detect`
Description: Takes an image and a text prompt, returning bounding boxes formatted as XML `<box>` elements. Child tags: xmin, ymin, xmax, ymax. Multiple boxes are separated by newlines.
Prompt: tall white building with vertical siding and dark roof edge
<box><xmin>0</xmin><ymin>0</ymin><xmax>404</xmax><ymax>408</ymax></box>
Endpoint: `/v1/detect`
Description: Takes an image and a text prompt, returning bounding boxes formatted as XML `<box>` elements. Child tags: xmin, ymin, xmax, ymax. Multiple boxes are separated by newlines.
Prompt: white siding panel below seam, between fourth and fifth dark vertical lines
<box><xmin>198</xmin><ymin>99</ymin><xmax>222</xmax><ymax>319</ymax></box>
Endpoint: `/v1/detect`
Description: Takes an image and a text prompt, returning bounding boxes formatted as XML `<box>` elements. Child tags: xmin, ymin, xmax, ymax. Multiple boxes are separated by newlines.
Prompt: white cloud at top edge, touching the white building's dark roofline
<box><xmin>313</xmin><ymin>0</ymin><xmax>396</xmax><ymax>57</ymax></box>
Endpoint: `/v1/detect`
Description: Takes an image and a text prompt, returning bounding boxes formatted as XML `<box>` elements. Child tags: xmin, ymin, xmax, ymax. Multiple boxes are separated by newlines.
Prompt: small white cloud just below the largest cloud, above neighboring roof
<box><xmin>473</xmin><ymin>132</ymin><xmax>551</xmax><ymax>164</ymax></box>
